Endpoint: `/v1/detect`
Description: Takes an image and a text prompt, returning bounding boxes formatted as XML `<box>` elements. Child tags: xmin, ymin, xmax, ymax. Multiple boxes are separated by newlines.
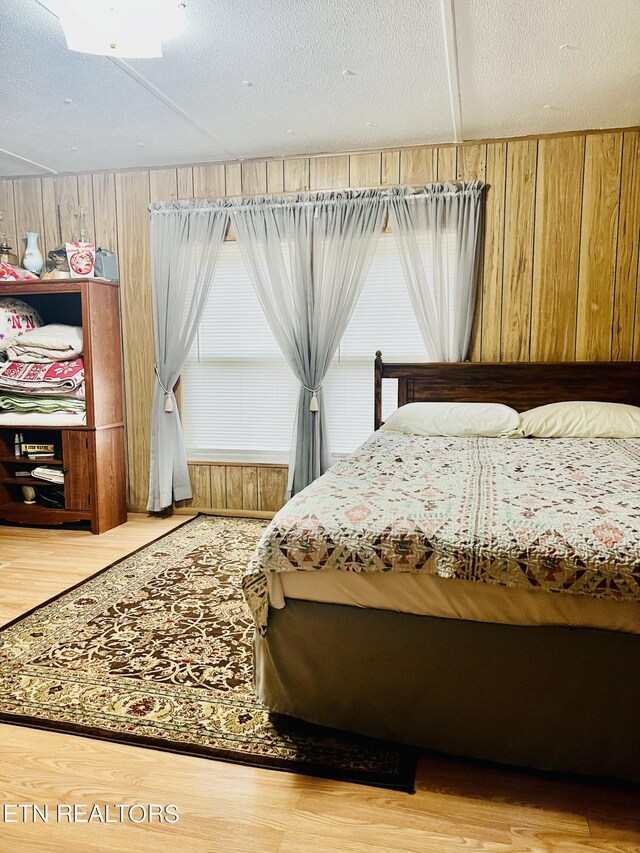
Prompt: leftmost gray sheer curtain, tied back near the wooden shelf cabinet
<box><xmin>147</xmin><ymin>201</ymin><xmax>228</xmax><ymax>512</ymax></box>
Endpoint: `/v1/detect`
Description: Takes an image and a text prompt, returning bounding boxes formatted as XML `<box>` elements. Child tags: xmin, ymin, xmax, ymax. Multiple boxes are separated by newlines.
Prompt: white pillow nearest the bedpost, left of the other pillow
<box><xmin>382</xmin><ymin>403</ymin><xmax>521</xmax><ymax>437</ymax></box>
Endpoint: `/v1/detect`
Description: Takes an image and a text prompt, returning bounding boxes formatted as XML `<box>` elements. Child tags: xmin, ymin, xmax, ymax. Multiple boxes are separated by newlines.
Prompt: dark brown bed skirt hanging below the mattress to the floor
<box><xmin>255</xmin><ymin>599</ymin><xmax>640</xmax><ymax>783</ymax></box>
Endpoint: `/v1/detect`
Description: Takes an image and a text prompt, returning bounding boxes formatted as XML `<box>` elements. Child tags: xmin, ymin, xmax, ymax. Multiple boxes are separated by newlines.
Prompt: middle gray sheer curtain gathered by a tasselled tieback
<box><xmin>230</xmin><ymin>190</ymin><xmax>384</xmax><ymax>497</ymax></box>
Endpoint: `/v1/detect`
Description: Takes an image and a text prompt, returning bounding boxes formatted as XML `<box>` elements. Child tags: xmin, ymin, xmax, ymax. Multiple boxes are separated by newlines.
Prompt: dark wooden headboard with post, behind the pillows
<box><xmin>374</xmin><ymin>351</ymin><xmax>640</xmax><ymax>429</ymax></box>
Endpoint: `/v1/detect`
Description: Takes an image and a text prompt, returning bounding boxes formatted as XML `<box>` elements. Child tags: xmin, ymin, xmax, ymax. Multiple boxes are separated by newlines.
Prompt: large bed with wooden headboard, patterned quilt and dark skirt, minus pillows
<box><xmin>244</xmin><ymin>353</ymin><xmax>640</xmax><ymax>782</ymax></box>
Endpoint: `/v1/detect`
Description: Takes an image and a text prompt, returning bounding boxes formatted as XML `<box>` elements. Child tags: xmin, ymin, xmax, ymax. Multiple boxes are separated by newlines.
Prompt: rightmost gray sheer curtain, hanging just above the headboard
<box><xmin>387</xmin><ymin>181</ymin><xmax>484</xmax><ymax>361</ymax></box>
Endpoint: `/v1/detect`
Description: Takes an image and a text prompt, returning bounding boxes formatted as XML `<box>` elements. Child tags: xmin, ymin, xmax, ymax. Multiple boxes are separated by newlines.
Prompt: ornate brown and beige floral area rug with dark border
<box><xmin>0</xmin><ymin>516</ymin><xmax>416</xmax><ymax>791</ymax></box>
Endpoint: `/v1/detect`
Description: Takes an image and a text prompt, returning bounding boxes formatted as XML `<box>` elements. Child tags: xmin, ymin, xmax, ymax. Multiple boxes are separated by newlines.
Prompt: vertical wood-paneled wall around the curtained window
<box><xmin>0</xmin><ymin>129</ymin><xmax>640</xmax><ymax>512</ymax></box>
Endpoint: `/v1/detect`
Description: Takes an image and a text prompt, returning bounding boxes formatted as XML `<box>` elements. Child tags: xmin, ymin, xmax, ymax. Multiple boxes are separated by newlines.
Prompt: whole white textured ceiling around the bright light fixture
<box><xmin>0</xmin><ymin>0</ymin><xmax>640</xmax><ymax>176</ymax></box>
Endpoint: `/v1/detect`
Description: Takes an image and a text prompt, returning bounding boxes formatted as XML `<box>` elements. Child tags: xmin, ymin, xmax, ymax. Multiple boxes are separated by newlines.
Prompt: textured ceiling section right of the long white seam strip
<box><xmin>456</xmin><ymin>0</ymin><xmax>640</xmax><ymax>139</ymax></box>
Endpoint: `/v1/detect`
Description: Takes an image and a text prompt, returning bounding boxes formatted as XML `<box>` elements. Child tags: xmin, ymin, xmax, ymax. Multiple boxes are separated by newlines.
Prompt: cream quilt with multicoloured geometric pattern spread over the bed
<box><xmin>243</xmin><ymin>432</ymin><xmax>640</xmax><ymax>633</ymax></box>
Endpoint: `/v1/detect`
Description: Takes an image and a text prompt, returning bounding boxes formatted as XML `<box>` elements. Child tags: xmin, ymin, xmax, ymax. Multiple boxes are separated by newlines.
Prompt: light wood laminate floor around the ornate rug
<box><xmin>0</xmin><ymin>515</ymin><xmax>640</xmax><ymax>853</ymax></box>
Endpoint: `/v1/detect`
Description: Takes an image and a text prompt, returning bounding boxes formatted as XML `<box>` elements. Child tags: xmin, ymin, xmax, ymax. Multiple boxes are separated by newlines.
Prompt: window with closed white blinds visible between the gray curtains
<box><xmin>181</xmin><ymin>234</ymin><xmax>426</xmax><ymax>462</ymax></box>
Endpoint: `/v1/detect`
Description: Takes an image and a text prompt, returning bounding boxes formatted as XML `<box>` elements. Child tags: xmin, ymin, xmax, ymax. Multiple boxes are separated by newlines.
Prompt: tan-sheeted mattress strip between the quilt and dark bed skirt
<box><xmin>267</xmin><ymin>571</ymin><xmax>640</xmax><ymax>634</ymax></box>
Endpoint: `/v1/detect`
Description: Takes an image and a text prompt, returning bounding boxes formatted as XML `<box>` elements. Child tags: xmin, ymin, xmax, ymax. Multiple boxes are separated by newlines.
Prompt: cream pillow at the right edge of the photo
<box><xmin>521</xmin><ymin>400</ymin><xmax>640</xmax><ymax>438</ymax></box>
